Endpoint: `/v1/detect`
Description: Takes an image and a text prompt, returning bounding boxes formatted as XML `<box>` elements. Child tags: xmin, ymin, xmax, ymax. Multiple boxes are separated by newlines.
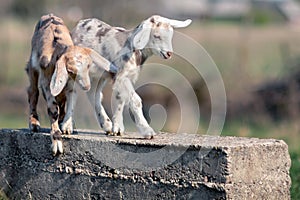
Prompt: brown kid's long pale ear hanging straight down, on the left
<box><xmin>50</xmin><ymin>56</ymin><xmax>69</xmax><ymax>96</ymax></box>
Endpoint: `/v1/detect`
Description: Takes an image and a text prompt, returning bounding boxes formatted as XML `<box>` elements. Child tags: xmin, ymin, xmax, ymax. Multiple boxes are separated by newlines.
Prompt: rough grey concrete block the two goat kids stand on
<box><xmin>0</xmin><ymin>129</ymin><xmax>291</xmax><ymax>199</ymax></box>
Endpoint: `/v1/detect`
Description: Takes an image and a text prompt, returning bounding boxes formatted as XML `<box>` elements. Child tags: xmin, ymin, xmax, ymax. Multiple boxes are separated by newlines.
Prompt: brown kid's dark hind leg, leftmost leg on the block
<box><xmin>27</xmin><ymin>65</ymin><xmax>40</xmax><ymax>132</ymax></box>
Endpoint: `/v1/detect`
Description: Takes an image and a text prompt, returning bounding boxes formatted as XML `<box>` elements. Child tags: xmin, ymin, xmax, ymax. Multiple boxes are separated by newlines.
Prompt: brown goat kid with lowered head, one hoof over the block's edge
<box><xmin>26</xmin><ymin>14</ymin><xmax>114</xmax><ymax>155</ymax></box>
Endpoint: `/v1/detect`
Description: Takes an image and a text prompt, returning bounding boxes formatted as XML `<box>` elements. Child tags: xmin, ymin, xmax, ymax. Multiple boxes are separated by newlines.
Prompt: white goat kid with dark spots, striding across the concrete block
<box><xmin>71</xmin><ymin>15</ymin><xmax>192</xmax><ymax>138</ymax></box>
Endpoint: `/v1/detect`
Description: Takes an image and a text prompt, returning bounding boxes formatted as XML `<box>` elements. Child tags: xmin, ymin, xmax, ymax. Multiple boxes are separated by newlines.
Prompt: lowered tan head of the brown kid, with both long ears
<box><xmin>50</xmin><ymin>46</ymin><xmax>114</xmax><ymax>96</ymax></box>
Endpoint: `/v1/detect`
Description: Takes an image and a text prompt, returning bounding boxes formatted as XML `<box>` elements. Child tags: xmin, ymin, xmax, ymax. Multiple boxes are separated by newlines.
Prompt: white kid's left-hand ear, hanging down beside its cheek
<box><xmin>133</xmin><ymin>21</ymin><xmax>151</xmax><ymax>49</ymax></box>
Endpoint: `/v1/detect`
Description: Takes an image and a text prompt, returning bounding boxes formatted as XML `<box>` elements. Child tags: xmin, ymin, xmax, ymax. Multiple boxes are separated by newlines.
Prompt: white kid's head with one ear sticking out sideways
<box><xmin>133</xmin><ymin>15</ymin><xmax>192</xmax><ymax>59</ymax></box>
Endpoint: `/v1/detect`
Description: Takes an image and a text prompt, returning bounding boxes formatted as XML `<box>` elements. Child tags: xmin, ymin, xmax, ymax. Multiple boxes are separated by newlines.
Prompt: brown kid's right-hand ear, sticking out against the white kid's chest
<box><xmin>86</xmin><ymin>48</ymin><xmax>117</xmax><ymax>73</ymax></box>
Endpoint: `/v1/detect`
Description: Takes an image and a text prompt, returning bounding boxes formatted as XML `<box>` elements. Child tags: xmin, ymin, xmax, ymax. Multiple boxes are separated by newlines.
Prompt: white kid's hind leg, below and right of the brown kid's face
<box><xmin>87</xmin><ymin>78</ymin><xmax>112</xmax><ymax>134</ymax></box>
